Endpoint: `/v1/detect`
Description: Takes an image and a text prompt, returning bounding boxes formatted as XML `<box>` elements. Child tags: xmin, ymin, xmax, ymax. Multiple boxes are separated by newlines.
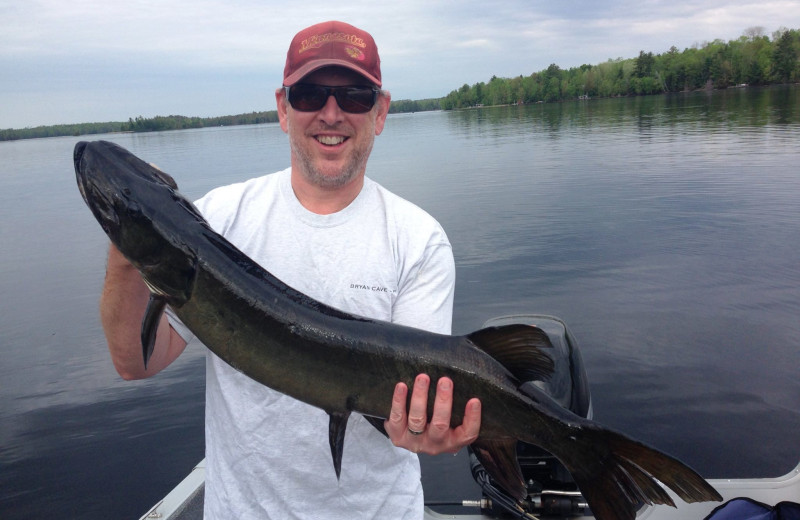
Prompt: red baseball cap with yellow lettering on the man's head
<box><xmin>283</xmin><ymin>21</ymin><xmax>381</xmax><ymax>87</ymax></box>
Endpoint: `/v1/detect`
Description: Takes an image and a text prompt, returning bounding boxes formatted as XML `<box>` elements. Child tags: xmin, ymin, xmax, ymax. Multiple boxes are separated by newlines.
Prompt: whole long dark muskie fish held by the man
<box><xmin>74</xmin><ymin>141</ymin><xmax>721</xmax><ymax>520</ymax></box>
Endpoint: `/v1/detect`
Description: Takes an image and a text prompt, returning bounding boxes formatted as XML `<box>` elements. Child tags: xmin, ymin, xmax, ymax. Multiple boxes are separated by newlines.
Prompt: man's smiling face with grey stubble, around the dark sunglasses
<box><xmin>275</xmin><ymin>67</ymin><xmax>389</xmax><ymax>188</ymax></box>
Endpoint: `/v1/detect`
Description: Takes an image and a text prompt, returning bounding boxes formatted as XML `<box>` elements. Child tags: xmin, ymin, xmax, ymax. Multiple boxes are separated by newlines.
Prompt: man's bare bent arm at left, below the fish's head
<box><xmin>100</xmin><ymin>245</ymin><xmax>185</xmax><ymax>379</ymax></box>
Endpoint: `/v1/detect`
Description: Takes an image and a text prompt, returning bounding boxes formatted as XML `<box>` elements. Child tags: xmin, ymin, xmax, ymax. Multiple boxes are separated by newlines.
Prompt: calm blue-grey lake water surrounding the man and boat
<box><xmin>0</xmin><ymin>88</ymin><xmax>800</xmax><ymax>519</ymax></box>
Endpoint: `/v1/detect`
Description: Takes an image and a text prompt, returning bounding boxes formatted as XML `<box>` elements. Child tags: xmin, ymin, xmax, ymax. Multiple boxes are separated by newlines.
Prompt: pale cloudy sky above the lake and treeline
<box><xmin>0</xmin><ymin>0</ymin><xmax>800</xmax><ymax>129</ymax></box>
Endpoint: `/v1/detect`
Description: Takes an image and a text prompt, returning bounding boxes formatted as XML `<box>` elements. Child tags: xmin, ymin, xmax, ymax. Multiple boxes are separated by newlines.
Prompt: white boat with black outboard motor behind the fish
<box><xmin>141</xmin><ymin>314</ymin><xmax>800</xmax><ymax>520</ymax></box>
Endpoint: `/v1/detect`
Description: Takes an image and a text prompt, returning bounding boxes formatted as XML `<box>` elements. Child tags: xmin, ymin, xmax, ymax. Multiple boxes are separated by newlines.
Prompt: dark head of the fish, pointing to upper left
<box><xmin>73</xmin><ymin>141</ymin><xmax>199</xmax><ymax>306</ymax></box>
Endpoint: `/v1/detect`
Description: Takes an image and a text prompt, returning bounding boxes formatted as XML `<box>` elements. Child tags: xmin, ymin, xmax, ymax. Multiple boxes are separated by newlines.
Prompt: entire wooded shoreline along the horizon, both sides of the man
<box><xmin>0</xmin><ymin>27</ymin><xmax>800</xmax><ymax>141</ymax></box>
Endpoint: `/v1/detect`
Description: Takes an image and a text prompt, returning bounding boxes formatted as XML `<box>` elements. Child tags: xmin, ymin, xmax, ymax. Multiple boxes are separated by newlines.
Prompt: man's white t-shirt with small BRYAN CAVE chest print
<box><xmin>170</xmin><ymin>169</ymin><xmax>455</xmax><ymax>520</ymax></box>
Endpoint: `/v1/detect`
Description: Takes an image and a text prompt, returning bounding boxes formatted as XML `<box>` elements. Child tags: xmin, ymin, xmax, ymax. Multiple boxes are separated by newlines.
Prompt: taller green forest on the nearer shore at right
<box><xmin>441</xmin><ymin>27</ymin><xmax>800</xmax><ymax>110</ymax></box>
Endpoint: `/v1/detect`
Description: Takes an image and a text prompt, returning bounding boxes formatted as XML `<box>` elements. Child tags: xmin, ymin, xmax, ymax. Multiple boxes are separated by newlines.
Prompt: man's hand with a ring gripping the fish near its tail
<box><xmin>384</xmin><ymin>374</ymin><xmax>481</xmax><ymax>455</ymax></box>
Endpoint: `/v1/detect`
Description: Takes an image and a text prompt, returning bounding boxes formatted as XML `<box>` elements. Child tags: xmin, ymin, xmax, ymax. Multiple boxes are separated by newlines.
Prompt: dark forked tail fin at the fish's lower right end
<box><xmin>559</xmin><ymin>424</ymin><xmax>722</xmax><ymax>520</ymax></box>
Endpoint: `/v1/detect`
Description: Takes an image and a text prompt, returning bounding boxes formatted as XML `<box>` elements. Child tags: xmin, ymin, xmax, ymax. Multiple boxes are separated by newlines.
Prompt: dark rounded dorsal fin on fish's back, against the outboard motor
<box><xmin>467</xmin><ymin>324</ymin><xmax>555</xmax><ymax>381</ymax></box>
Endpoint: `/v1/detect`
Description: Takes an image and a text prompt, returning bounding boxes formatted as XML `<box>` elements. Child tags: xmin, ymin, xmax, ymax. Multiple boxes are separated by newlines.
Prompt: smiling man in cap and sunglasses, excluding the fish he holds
<box><xmin>101</xmin><ymin>22</ymin><xmax>480</xmax><ymax>519</ymax></box>
